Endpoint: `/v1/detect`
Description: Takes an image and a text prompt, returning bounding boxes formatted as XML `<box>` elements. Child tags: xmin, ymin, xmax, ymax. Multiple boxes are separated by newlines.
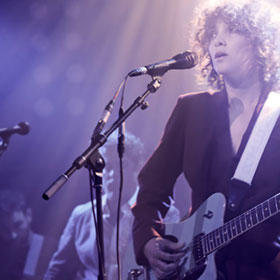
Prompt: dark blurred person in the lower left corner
<box><xmin>0</xmin><ymin>190</ymin><xmax>56</xmax><ymax>280</ymax></box>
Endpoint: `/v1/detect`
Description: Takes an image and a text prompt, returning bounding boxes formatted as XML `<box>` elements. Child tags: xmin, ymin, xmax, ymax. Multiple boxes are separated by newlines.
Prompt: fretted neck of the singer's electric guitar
<box><xmin>201</xmin><ymin>193</ymin><xmax>280</xmax><ymax>255</ymax></box>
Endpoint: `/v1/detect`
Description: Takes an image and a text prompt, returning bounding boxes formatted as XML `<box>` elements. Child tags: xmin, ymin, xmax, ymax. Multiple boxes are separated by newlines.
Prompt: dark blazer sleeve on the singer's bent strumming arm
<box><xmin>132</xmin><ymin>94</ymin><xmax>187</xmax><ymax>265</ymax></box>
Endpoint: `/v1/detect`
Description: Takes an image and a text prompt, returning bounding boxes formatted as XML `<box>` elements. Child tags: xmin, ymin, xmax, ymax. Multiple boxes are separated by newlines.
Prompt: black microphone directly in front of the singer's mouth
<box><xmin>127</xmin><ymin>51</ymin><xmax>198</xmax><ymax>77</ymax></box>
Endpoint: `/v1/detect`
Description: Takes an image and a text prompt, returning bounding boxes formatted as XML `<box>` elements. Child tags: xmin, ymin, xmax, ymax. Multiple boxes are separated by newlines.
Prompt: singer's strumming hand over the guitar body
<box><xmin>144</xmin><ymin>237</ymin><xmax>185</xmax><ymax>279</ymax></box>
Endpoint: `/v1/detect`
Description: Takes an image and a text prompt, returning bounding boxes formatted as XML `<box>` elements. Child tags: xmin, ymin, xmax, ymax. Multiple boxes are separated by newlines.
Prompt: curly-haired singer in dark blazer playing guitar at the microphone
<box><xmin>133</xmin><ymin>0</ymin><xmax>280</xmax><ymax>280</ymax></box>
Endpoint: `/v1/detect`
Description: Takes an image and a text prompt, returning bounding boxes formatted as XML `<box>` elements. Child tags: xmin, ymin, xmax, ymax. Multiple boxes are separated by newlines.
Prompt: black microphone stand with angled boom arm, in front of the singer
<box><xmin>42</xmin><ymin>76</ymin><xmax>161</xmax><ymax>280</ymax></box>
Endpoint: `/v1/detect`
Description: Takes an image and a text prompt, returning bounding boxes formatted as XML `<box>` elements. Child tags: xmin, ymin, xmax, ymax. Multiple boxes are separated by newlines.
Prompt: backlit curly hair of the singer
<box><xmin>191</xmin><ymin>0</ymin><xmax>280</xmax><ymax>91</ymax></box>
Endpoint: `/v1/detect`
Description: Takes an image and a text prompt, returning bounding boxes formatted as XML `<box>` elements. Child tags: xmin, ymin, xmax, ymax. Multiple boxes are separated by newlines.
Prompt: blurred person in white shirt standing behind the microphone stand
<box><xmin>44</xmin><ymin>132</ymin><xmax>176</xmax><ymax>280</ymax></box>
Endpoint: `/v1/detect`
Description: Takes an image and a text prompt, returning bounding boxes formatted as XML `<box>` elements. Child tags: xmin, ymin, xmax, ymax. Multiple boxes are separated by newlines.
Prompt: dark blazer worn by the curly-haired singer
<box><xmin>133</xmin><ymin>91</ymin><xmax>280</xmax><ymax>264</ymax></box>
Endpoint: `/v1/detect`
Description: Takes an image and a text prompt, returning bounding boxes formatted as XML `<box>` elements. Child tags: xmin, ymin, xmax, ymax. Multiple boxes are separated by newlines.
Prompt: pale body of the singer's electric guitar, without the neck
<box><xmin>137</xmin><ymin>193</ymin><xmax>226</xmax><ymax>280</ymax></box>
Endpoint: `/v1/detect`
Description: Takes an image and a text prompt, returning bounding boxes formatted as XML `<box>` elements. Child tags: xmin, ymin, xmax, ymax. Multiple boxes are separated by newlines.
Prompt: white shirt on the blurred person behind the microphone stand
<box><xmin>44</xmin><ymin>195</ymin><xmax>133</xmax><ymax>280</ymax></box>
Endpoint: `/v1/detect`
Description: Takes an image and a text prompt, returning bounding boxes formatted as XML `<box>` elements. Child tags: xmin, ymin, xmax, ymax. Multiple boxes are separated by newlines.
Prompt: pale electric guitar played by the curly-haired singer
<box><xmin>127</xmin><ymin>193</ymin><xmax>280</xmax><ymax>280</ymax></box>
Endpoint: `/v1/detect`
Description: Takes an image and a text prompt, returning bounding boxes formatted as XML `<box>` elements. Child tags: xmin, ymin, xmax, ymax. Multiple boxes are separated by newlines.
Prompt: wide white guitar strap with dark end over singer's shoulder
<box><xmin>228</xmin><ymin>91</ymin><xmax>280</xmax><ymax>210</ymax></box>
